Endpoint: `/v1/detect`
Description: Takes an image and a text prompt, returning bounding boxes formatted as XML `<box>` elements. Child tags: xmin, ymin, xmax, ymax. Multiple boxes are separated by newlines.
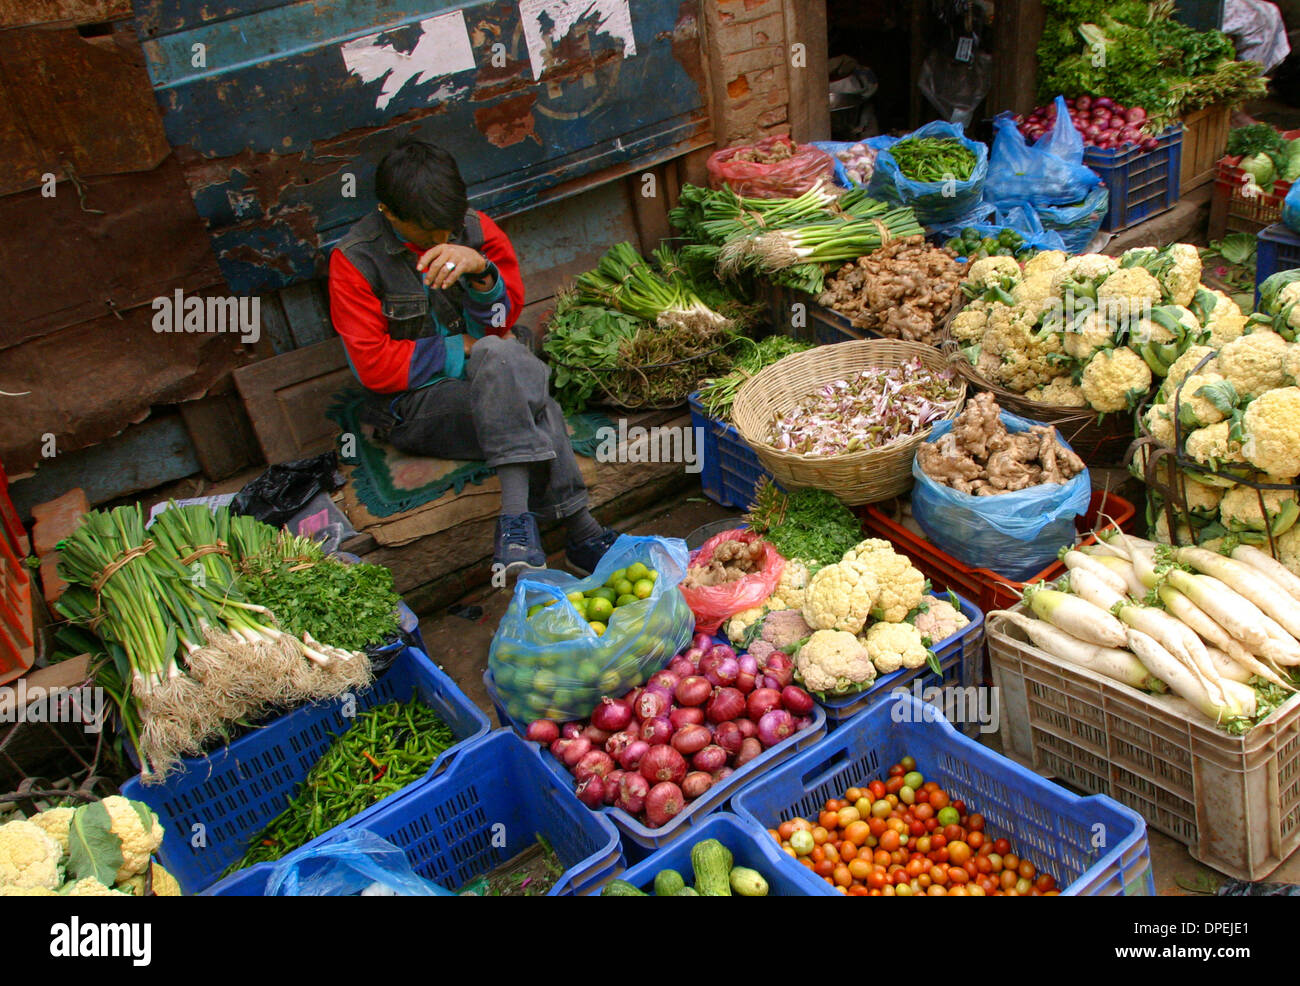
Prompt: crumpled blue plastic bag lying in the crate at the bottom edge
<box><xmin>263</xmin><ymin>829</ymin><xmax>455</xmax><ymax>898</ymax></box>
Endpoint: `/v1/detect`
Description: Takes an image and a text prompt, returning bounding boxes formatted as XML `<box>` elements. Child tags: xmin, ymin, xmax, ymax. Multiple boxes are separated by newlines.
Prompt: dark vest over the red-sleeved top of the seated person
<box><xmin>334</xmin><ymin>209</ymin><xmax>484</xmax><ymax>340</ymax></box>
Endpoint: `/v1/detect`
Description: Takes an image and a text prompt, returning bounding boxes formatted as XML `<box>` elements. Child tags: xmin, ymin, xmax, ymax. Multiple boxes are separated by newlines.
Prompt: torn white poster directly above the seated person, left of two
<box><xmin>342</xmin><ymin>10</ymin><xmax>475</xmax><ymax>109</ymax></box>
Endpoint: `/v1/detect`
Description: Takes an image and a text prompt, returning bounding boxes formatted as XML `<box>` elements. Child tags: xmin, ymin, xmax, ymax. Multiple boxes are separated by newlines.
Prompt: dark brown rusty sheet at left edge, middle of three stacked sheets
<box><xmin>0</xmin><ymin>155</ymin><xmax>221</xmax><ymax>351</ymax></box>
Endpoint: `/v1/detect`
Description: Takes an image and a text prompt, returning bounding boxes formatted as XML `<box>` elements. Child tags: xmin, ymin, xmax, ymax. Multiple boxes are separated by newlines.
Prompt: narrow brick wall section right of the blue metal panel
<box><xmin>703</xmin><ymin>0</ymin><xmax>790</xmax><ymax>147</ymax></box>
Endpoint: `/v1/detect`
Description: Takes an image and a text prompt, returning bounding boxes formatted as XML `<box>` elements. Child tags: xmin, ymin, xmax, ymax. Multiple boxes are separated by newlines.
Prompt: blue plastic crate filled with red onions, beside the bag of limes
<box><xmin>484</xmin><ymin>671</ymin><xmax>826</xmax><ymax>855</ymax></box>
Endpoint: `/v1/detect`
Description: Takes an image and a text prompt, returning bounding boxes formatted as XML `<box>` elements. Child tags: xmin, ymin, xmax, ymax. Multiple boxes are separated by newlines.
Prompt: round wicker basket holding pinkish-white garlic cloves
<box><xmin>732</xmin><ymin>340</ymin><xmax>966</xmax><ymax>506</ymax></box>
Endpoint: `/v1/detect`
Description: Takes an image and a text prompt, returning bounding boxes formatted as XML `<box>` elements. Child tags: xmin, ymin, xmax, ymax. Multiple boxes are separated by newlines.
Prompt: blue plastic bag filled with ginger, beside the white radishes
<box><xmin>911</xmin><ymin>411</ymin><xmax>1092</xmax><ymax>581</ymax></box>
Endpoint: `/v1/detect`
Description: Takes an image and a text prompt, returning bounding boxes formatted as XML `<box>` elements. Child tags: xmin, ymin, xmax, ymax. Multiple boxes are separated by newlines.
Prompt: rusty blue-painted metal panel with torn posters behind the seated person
<box><xmin>137</xmin><ymin>0</ymin><xmax>711</xmax><ymax>291</ymax></box>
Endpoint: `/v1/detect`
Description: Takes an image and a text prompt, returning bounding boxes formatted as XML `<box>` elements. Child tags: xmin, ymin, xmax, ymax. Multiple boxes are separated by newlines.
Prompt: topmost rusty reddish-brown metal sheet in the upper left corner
<box><xmin>0</xmin><ymin>23</ymin><xmax>169</xmax><ymax>195</ymax></box>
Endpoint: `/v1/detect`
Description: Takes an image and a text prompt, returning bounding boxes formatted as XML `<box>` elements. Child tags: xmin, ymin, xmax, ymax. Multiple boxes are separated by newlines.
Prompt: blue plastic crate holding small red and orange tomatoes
<box><xmin>732</xmin><ymin>695</ymin><xmax>1156</xmax><ymax>896</ymax></box>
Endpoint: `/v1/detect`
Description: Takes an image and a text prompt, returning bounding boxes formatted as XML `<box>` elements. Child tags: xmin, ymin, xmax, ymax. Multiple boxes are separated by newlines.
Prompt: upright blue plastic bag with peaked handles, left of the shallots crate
<box><xmin>984</xmin><ymin>104</ymin><xmax>1101</xmax><ymax>206</ymax></box>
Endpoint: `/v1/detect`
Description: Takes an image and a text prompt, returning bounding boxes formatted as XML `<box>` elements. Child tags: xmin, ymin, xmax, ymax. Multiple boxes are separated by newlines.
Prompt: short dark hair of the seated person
<box><xmin>374</xmin><ymin>137</ymin><xmax>469</xmax><ymax>234</ymax></box>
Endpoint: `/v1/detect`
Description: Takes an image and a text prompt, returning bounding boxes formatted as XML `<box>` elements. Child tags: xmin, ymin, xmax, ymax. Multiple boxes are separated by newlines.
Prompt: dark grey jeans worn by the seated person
<box><xmin>389</xmin><ymin>336</ymin><xmax>588</xmax><ymax>520</ymax></box>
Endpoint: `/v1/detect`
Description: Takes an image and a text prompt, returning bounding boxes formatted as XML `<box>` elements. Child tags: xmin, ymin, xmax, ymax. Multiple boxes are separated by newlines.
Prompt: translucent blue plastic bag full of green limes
<box><xmin>488</xmin><ymin>535</ymin><xmax>694</xmax><ymax>722</ymax></box>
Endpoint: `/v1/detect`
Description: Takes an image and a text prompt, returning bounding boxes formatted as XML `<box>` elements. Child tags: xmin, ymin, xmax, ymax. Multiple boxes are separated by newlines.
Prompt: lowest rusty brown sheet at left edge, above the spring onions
<box><xmin>0</xmin><ymin>291</ymin><xmax>252</xmax><ymax>477</ymax></box>
